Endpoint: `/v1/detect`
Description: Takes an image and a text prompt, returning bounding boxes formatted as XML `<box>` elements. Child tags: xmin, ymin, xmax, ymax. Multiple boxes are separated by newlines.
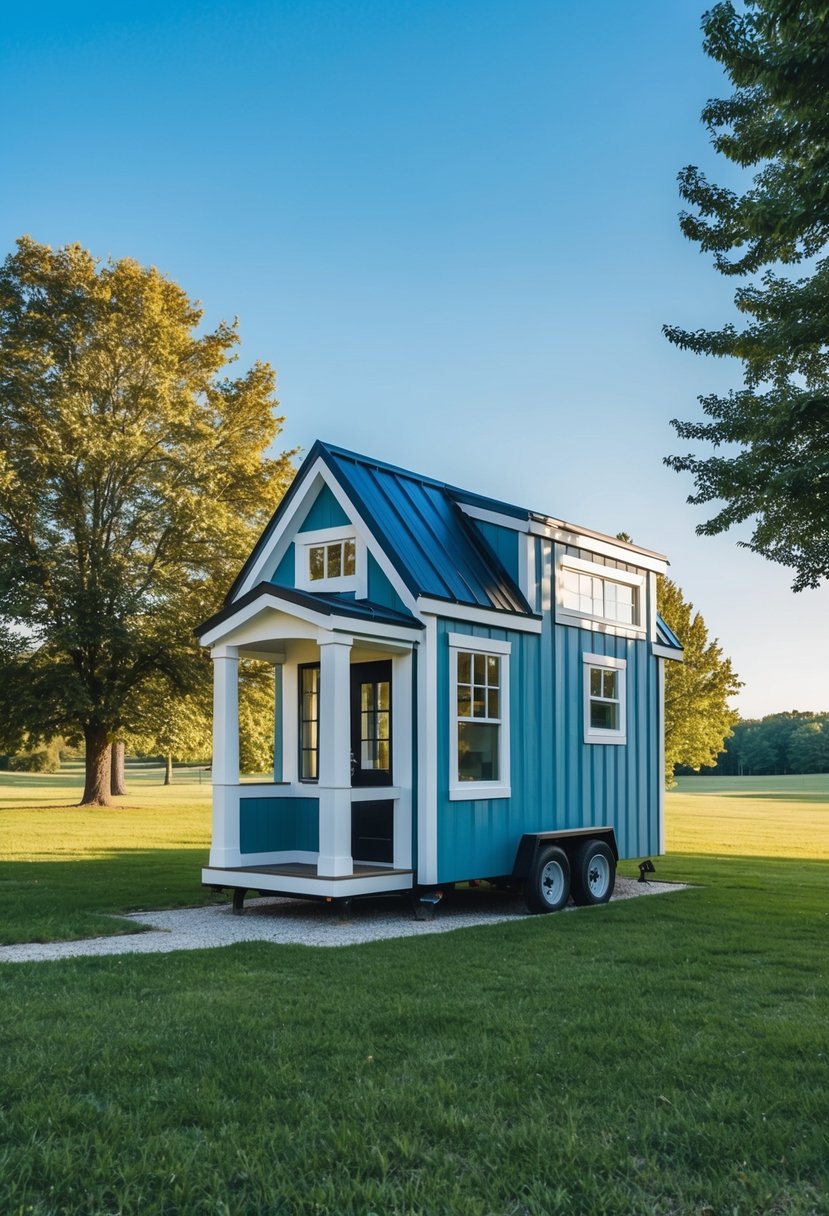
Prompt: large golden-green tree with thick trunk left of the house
<box><xmin>0</xmin><ymin>238</ymin><xmax>291</xmax><ymax>805</ymax></box>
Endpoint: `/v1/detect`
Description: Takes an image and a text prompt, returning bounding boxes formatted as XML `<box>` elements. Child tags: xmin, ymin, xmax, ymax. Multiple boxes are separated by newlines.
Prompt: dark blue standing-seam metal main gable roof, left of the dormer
<box><xmin>226</xmin><ymin>441</ymin><xmax>532</xmax><ymax>615</ymax></box>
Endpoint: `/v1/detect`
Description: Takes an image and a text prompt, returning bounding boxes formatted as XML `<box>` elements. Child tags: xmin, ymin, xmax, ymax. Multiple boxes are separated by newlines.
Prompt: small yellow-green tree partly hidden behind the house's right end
<box><xmin>658</xmin><ymin>576</ymin><xmax>743</xmax><ymax>786</ymax></box>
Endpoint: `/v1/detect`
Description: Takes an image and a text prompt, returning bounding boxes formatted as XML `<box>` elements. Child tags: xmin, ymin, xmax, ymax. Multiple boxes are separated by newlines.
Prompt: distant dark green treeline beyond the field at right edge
<box><xmin>677</xmin><ymin>710</ymin><xmax>829</xmax><ymax>777</ymax></box>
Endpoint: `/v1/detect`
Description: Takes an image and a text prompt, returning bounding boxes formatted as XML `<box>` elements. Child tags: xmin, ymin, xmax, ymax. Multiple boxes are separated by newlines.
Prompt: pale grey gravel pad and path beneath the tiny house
<box><xmin>0</xmin><ymin>878</ymin><xmax>684</xmax><ymax>963</ymax></box>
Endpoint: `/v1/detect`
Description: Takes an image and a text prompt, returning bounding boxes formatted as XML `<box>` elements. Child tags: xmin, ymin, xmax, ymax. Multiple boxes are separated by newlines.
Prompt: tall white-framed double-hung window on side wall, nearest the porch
<box><xmin>449</xmin><ymin>634</ymin><xmax>511</xmax><ymax>799</ymax></box>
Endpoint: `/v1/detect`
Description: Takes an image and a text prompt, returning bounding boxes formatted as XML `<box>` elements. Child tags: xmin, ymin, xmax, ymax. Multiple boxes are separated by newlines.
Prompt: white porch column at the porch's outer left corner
<box><xmin>210</xmin><ymin>646</ymin><xmax>239</xmax><ymax>867</ymax></box>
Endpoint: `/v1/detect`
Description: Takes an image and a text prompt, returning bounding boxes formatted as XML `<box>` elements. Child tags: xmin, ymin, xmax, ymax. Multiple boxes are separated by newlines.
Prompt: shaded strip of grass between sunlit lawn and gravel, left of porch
<box><xmin>0</xmin><ymin>849</ymin><xmax>227</xmax><ymax>945</ymax></box>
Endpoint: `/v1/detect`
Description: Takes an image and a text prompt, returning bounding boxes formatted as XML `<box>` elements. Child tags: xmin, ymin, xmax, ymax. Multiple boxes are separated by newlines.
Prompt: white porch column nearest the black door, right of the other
<box><xmin>317</xmin><ymin>634</ymin><xmax>354</xmax><ymax>878</ymax></box>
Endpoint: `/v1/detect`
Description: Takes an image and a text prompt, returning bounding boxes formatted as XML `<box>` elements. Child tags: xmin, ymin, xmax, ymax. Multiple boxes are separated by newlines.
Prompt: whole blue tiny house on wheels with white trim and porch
<box><xmin>197</xmin><ymin>443</ymin><xmax>682</xmax><ymax>911</ymax></box>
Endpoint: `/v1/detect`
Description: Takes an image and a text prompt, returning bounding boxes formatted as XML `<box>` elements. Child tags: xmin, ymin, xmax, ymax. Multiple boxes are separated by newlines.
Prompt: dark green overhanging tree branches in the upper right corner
<box><xmin>665</xmin><ymin>0</ymin><xmax>829</xmax><ymax>591</ymax></box>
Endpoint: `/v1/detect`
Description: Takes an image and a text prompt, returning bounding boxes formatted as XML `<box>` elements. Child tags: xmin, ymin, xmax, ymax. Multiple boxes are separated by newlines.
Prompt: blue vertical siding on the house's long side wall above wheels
<box><xmin>438</xmin><ymin>541</ymin><xmax>661</xmax><ymax>883</ymax></box>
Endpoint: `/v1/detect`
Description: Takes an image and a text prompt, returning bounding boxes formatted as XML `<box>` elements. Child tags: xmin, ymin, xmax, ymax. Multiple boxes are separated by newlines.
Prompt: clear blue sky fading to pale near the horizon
<box><xmin>0</xmin><ymin>0</ymin><xmax>829</xmax><ymax>715</ymax></box>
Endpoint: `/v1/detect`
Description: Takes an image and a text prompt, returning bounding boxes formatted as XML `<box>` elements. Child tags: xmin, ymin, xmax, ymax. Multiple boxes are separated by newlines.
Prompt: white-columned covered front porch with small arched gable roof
<box><xmin>202</xmin><ymin>584</ymin><xmax>419</xmax><ymax>899</ymax></box>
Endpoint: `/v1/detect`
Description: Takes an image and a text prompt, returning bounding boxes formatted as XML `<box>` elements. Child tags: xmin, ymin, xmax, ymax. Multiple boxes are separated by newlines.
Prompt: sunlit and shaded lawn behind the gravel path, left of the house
<box><xmin>0</xmin><ymin>765</ymin><xmax>216</xmax><ymax>945</ymax></box>
